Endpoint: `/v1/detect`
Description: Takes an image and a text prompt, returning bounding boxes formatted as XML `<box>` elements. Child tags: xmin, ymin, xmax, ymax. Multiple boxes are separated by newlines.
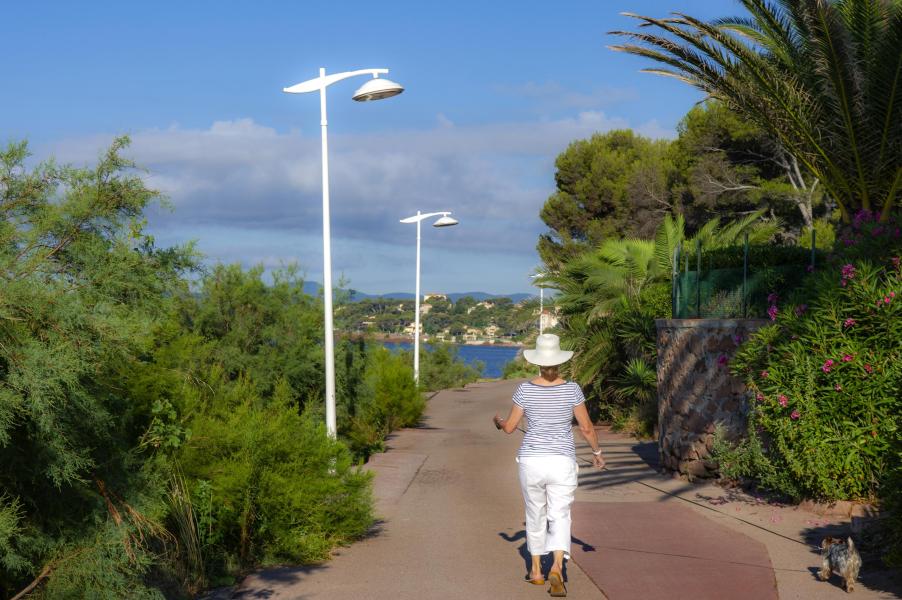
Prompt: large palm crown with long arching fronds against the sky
<box><xmin>611</xmin><ymin>0</ymin><xmax>902</xmax><ymax>223</ymax></box>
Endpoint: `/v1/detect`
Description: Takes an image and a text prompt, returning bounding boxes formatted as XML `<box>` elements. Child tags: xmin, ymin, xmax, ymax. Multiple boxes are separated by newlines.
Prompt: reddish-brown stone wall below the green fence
<box><xmin>655</xmin><ymin>319</ymin><xmax>767</xmax><ymax>478</ymax></box>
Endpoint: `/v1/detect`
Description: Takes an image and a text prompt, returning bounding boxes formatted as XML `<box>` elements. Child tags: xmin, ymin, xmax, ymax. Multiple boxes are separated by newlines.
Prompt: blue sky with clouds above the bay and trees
<box><xmin>0</xmin><ymin>0</ymin><xmax>739</xmax><ymax>293</ymax></box>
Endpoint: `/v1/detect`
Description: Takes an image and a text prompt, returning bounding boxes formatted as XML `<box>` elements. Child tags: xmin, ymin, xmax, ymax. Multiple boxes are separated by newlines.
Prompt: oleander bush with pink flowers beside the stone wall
<box><xmin>717</xmin><ymin>255</ymin><xmax>902</xmax><ymax>499</ymax></box>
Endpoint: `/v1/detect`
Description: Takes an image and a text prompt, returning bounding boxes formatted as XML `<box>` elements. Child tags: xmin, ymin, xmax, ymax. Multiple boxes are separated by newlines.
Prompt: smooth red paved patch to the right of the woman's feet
<box><xmin>571</xmin><ymin>502</ymin><xmax>778</xmax><ymax>600</ymax></box>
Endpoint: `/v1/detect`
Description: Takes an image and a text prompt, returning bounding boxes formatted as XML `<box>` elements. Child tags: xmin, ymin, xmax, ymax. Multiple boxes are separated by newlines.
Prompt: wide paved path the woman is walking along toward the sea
<box><xmin>217</xmin><ymin>382</ymin><xmax>897</xmax><ymax>600</ymax></box>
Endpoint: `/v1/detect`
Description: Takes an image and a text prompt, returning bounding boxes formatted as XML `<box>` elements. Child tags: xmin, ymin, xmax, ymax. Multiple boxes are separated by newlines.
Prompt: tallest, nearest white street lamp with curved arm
<box><xmin>282</xmin><ymin>68</ymin><xmax>404</xmax><ymax>438</ymax></box>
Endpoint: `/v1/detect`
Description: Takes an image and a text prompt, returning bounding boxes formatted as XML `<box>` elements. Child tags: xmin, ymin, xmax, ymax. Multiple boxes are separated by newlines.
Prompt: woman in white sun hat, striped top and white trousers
<box><xmin>492</xmin><ymin>333</ymin><xmax>604</xmax><ymax>597</ymax></box>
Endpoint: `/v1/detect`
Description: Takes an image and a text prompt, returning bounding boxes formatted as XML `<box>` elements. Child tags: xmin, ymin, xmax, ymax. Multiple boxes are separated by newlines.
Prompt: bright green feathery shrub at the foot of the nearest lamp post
<box><xmin>177</xmin><ymin>379</ymin><xmax>372</xmax><ymax>583</ymax></box>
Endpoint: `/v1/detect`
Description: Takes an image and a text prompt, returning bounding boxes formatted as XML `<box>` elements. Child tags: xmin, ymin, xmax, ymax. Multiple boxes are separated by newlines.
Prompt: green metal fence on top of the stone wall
<box><xmin>671</xmin><ymin>236</ymin><xmax>820</xmax><ymax>319</ymax></box>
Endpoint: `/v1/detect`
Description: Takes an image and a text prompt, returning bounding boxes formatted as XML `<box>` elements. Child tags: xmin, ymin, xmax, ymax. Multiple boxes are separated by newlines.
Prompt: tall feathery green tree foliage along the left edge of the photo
<box><xmin>0</xmin><ymin>139</ymin><xmax>194</xmax><ymax>597</ymax></box>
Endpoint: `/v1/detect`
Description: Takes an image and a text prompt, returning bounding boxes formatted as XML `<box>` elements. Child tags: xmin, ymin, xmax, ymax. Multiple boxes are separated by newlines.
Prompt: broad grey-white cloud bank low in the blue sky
<box><xmin>44</xmin><ymin>110</ymin><xmax>657</xmax><ymax>291</ymax></box>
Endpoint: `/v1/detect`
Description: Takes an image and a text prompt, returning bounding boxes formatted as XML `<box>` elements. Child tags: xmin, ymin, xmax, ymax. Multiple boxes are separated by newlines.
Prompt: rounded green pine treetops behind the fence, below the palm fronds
<box><xmin>538</xmin><ymin>101</ymin><xmax>828</xmax><ymax>269</ymax></box>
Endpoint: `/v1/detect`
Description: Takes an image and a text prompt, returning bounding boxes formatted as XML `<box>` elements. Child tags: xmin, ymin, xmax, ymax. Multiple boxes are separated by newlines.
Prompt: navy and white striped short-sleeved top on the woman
<box><xmin>514</xmin><ymin>381</ymin><xmax>586</xmax><ymax>460</ymax></box>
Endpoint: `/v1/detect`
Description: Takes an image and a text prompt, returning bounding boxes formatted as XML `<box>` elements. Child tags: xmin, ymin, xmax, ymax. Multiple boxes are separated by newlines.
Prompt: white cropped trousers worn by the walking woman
<box><xmin>517</xmin><ymin>455</ymin><xmax>579</xmax><ymax>559</ymax></box>
